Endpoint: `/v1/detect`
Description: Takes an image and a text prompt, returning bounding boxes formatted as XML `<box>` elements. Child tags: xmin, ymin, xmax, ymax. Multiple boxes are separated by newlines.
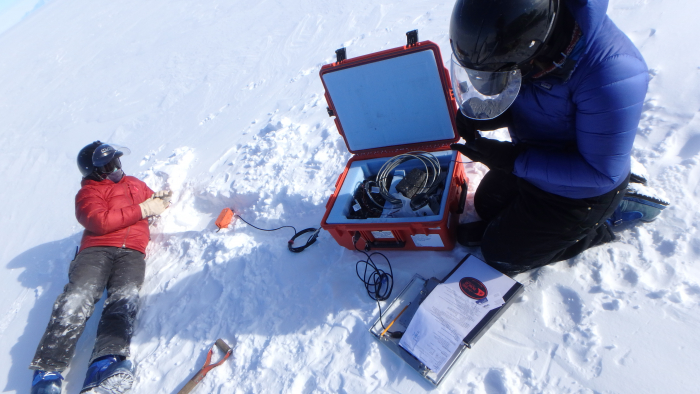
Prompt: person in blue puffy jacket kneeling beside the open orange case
<box><xmin>450</xmin><ymin>0</ymin><xmax>649</xmax><ymax>274</ymax></box>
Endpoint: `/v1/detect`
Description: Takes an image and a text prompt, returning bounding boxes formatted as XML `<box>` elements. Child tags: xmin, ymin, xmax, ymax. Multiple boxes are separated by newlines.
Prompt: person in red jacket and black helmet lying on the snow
<box><xmin>29</xmin><ymin>141</ymin><xmax>170</xmax><ymax>394</ymax></box>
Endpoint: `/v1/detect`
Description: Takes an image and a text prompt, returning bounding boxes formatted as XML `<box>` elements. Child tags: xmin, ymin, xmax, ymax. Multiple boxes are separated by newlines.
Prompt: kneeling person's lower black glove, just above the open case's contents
<box><xmin>450</xmin><ymin>138</ymin><xmax>523</xmax><ymax>173</ymax></box>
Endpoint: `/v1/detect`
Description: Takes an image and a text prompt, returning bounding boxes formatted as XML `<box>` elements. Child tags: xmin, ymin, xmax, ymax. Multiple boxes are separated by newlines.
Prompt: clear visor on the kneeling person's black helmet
<box><xmin>450</xmin><ymin>55</ymin><xmax>522</xmax><ymax>120</ymax></box>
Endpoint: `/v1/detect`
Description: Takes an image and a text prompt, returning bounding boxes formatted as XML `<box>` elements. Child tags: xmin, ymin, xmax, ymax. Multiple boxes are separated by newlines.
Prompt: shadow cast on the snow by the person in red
<box><xmin>3</xmin><ymin>232</ymin><xmax>104</xmax><ymax>393</ymax></box>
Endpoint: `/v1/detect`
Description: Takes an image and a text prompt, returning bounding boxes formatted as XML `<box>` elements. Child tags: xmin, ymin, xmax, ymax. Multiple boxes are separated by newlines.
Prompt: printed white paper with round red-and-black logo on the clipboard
<box><xmin>399</xmin><ymin>256</ymin><xmax>516</xmax><ymax>372</ymax></box>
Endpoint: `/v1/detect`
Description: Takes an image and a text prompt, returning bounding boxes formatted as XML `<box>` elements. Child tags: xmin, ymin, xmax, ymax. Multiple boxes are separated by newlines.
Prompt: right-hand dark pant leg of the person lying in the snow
<box><xmin>90</xmin><ymin>249</ymin><xmax>146</xmax><ymax>362</ymax></box>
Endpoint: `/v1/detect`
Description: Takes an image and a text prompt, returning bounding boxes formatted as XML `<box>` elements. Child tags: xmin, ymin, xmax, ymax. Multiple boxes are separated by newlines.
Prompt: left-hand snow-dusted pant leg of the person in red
<box><xmin>29</xmin><ymin>247</ymin><xmax>117</xmax><ymax>372</ymax></box>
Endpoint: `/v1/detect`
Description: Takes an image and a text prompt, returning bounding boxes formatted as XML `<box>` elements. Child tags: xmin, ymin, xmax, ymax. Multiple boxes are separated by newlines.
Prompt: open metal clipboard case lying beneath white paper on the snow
<box><xmin>369</xmin><ymin>254</ymin><xmax>524</xmax><ymax>387</ymax></box>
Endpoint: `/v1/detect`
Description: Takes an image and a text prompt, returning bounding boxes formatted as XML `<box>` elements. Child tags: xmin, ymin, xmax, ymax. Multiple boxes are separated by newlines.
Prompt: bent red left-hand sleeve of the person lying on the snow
<box><xmin>75</xmin><ymin>189</ymin><xmax>142</xmax><ymax>235</ymax></box>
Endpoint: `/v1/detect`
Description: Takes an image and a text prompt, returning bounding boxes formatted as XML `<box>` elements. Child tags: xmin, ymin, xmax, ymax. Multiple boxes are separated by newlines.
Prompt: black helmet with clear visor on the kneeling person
<box><xmin>450</xmin><ymin>0</ymin><xmax>559</xmax><ymax>119</ymax></box>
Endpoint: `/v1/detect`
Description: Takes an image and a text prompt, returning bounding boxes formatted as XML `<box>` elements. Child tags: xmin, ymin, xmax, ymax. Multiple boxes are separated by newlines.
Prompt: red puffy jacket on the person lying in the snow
<box><xmin>75</xmin><ymin>175</ymin><xmax>153</xmax><ymax>253</ymax></box>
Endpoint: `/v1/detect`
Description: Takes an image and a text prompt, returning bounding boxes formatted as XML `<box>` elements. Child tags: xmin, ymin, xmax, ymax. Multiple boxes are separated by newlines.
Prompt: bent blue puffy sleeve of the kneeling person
<box><xmin>513</xmin><ymin>55</ymin><xmax>648</xmax><ymax>187</ymax></box>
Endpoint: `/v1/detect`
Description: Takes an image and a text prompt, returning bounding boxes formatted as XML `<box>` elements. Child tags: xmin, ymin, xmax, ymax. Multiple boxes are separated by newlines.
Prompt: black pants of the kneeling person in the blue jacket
<box><xmin>474</xmin><ymin>170</ymin><xmax>629</xmax><ymax>273</ymax></box>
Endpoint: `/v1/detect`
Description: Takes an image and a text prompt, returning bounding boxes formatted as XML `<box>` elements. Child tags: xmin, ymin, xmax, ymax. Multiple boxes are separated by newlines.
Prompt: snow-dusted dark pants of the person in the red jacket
<box><xmin>29</xmin><ymin>246</ymin><xmax>146</xmax><ymax>372</ymax></box>
